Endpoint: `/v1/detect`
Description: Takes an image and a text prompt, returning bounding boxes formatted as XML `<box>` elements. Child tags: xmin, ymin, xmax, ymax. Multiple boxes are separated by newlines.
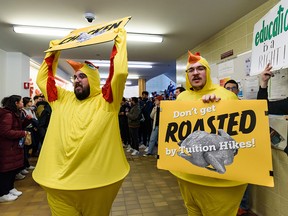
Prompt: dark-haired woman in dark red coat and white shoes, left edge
<box><xmin>0</xmin><ymin>95</ymin><xmax>30</xmax><ymax>202</ymax></box>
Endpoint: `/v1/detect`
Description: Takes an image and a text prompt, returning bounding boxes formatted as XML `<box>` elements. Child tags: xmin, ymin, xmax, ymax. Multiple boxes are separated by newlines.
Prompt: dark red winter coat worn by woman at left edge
<box><xmin>0</xmin><ymin>108</ymin><xmax>25</xmax><ymax>172</ymax></box>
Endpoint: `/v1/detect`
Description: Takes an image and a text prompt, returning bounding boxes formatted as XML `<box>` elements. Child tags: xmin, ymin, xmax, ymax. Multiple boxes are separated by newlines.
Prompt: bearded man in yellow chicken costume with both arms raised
<box><xmin>33</xmin><ymin>28</ymin><xmax>130</xmax><ymax>216</ymax></box>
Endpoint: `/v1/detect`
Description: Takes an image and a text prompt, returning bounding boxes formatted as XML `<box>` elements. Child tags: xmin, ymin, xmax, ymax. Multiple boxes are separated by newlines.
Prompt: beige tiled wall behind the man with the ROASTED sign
<box><xmin>176</xmin><ymin>0</ymin><xmax>288</xmax><ymax>216</ymax></box>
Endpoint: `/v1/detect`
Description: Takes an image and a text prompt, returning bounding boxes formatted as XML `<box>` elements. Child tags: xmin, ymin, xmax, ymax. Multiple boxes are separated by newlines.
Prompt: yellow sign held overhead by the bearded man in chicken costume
<box><xmin>45</xmin><ymin>16</ymin><xmax>131</xmax><ymax>52</ymax></box>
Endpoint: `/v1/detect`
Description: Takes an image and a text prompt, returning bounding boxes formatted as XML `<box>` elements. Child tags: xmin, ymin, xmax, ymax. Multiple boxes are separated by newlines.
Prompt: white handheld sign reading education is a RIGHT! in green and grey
<box><xmin>250</xmin><ymin>0</ymin><xmax>288</xmax><ymax>76</ymax></box>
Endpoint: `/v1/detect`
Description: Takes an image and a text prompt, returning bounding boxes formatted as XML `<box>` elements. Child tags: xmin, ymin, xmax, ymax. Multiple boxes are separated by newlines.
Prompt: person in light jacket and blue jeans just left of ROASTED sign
<box><xmin>143</xmin><ymin>95</ymin><xmax>163</xmax><ymax>157</ymax></box>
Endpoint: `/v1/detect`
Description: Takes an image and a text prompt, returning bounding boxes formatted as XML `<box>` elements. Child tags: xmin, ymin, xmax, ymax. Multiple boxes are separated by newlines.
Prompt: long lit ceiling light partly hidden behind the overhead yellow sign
<box><xmin>13</xmin><ymin>26</ymin><xmax>163</xmax><ymax>43</ymax></box>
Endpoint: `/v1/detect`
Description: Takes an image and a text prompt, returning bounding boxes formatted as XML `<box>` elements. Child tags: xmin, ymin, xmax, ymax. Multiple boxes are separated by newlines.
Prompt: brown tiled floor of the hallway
<box><xmin>0</xmin><ymin>148</ymin><xmax>187</xmax><ymax>216</ymax></box>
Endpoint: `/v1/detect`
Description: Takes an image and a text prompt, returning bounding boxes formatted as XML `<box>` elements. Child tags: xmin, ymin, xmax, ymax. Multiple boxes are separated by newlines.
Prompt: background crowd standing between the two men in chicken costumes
<box><xmin>119</xmin><ymin>87</ymin><xmax>185</xmax><ymax>157</ymax></box>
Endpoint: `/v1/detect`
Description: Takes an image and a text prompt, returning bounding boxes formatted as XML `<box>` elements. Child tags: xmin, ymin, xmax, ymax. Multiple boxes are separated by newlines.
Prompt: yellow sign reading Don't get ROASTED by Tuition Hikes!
<box><xmin>157</xmin><ymin>100</ymin><xmax>274</xmax><ymax>187</ymax></box>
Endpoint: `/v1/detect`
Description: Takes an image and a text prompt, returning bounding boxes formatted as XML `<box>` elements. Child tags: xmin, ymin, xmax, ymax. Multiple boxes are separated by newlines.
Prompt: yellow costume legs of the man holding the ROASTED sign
<box><xmin>178</xmin><ymin>178</ymin><xmax>247</xmax><ymax>216</ymax></box>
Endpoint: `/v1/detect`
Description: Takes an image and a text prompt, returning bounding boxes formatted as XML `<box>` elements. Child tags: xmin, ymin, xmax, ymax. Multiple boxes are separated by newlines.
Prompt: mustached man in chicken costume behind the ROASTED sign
<box><xmin>171</xmin><ymin>51</ymin><xmax>247</xmax><ymax>216</ymax></box>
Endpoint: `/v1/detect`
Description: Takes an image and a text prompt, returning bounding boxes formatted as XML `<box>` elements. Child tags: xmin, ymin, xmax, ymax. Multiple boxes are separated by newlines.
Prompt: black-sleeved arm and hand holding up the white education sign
<box><xmin>257</xmin><ymin>64</ymin><xmax>288</xmax><ymax>115</ymax></box>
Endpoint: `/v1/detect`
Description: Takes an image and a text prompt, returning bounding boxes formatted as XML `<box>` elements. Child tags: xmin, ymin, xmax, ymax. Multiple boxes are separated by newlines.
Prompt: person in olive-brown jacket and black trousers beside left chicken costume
<box><xmin>126</xmin><ymin>97</ymin><xmax>141</xmax><ymax>156</ymax></box>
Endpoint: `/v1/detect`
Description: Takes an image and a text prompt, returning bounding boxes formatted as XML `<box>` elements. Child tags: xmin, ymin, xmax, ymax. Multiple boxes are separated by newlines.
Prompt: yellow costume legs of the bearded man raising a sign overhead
<box><xmin>42</xmin><ymin>180</ymin><xmax>123</xmax><ymax>216</ymax></box>
